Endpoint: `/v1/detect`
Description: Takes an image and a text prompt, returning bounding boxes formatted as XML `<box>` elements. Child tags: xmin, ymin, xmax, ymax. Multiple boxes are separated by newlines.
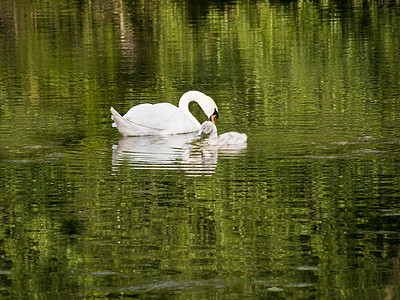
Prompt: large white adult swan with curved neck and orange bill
<box><xmin>110</xmin><ymin>91</ymin><xmax>218</xmax><ymax>136</ymax></box>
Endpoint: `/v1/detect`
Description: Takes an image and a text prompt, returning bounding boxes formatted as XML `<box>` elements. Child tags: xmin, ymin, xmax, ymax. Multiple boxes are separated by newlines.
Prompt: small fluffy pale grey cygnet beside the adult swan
<box><xmin>200</xmin><ymin>121</ymin><xmax>247</xmax><ymax>146</ymax></box>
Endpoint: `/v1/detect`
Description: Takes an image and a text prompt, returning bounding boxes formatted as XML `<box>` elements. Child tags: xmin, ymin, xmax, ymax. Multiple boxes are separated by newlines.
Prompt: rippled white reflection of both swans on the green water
<box><xmin>112</xmin><ymin>133</ymin><xmax>246</xmax><ymax>176</ymax></box>
